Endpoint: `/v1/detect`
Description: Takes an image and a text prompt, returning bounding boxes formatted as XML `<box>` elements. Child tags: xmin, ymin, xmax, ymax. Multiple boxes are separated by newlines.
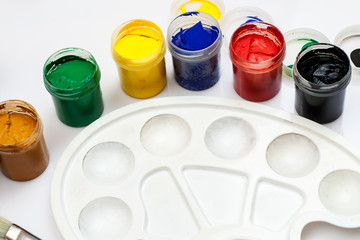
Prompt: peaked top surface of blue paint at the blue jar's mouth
<box><xmin>172</xmin><ymin>21</ymin><xmax>219</xmax><ymax>51</ymax></box>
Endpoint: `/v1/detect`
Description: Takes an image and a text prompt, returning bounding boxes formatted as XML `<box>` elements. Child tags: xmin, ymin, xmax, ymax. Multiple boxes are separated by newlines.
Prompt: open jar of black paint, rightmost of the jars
<box><xmin>293</xmin><ymin>43</ymin><xmax>351</xmax><ymax>123</ymax></box>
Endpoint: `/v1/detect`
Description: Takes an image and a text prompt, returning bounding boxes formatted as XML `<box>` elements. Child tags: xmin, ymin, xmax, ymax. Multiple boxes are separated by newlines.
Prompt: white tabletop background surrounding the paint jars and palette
<box><xmin>0</xmin><ymin>0</ymin><xmax>360</xmax><ymax>240</ymax></box>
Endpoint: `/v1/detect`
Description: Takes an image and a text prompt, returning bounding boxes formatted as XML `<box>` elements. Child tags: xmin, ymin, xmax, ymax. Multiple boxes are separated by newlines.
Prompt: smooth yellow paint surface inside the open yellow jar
<box><xmin>114</xmin><ymin>33</ymin><xmax>162</xmax><ymax>59</ymax></box>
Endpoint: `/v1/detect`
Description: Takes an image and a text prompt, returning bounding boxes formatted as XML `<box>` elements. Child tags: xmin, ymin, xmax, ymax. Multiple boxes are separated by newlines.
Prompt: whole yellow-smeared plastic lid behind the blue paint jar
<box><xmin>170</xmin><ymin>0</ymin><xmax>225</xmax><ymax>21</ymax></box>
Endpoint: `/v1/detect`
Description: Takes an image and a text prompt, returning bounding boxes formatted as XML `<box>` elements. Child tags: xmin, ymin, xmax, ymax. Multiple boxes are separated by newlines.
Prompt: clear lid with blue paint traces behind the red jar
<box><xmin>220</xmin><ymin>6</ymin><xmax>273</xmax><ymax>48</ymax></box>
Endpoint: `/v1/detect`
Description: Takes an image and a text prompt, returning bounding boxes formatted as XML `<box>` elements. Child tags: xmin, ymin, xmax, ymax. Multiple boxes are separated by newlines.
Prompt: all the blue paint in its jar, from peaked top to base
<box><xmin>171</xmin><ymin>21</ymin><xmax>222</xmax><ymax>91</ymax></box>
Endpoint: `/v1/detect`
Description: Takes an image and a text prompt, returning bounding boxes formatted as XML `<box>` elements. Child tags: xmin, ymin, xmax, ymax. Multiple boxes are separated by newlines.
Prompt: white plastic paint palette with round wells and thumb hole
<box><xmin>51</xmin><ymin>97</ymin><xmax>360</xmax><ymax>240</ymax></box>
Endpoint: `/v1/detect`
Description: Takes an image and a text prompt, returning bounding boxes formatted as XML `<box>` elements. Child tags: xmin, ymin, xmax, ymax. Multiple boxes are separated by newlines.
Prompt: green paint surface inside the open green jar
<box><xmin>47</xmin><ymin>59</ymin><xmax>96</xmax><ymax>89</ymax></box>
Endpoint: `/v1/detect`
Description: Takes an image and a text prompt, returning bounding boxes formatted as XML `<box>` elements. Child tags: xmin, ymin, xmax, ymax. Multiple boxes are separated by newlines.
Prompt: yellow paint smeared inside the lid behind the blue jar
<box><xmin>179</xmin><ymin>0</ymin><xmax>221</xmax><ymax>20</ymax></box>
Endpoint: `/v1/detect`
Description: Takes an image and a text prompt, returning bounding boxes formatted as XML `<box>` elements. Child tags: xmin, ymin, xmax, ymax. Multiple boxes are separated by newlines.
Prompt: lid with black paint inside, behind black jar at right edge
<box><xmin>334</xmin><ymin>25</ymin><xmax>360</xmax><ymax>75</ymax></box>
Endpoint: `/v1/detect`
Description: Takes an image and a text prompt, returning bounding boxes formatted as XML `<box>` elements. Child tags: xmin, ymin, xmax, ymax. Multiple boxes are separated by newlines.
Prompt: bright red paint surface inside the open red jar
<box><xmin>234</xmin><ymin>34</ymin><xmax>280</xmax><ymax>62</ymax></box>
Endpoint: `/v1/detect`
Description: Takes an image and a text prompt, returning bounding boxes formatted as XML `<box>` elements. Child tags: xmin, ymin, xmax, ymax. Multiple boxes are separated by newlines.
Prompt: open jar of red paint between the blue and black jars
<box><xmin>229</xmin><ymin>22</ymin><xmax>286</xmax><ymax>102</ymax></box>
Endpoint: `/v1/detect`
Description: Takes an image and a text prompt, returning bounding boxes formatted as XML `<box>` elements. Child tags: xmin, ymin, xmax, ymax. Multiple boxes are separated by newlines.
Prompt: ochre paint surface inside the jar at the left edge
<box><xmin>0</xmin><ymin>113</ymin><xmax>36</xmax><ymax>145</ymax></box>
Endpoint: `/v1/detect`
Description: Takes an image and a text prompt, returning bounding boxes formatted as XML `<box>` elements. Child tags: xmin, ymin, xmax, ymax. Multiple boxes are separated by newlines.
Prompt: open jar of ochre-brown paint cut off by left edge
<box><xmin>0</xmin><ymin>100</ymin><xmax>49</xmax><ymax>181</ymax></box>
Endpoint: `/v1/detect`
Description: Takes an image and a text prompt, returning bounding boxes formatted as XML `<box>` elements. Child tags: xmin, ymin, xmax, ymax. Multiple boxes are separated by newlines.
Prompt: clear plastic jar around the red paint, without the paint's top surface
<box><xmin>229</xmin><ymin>22</ymin><xmax>286</xmax><ymax>102</ymax></box>
